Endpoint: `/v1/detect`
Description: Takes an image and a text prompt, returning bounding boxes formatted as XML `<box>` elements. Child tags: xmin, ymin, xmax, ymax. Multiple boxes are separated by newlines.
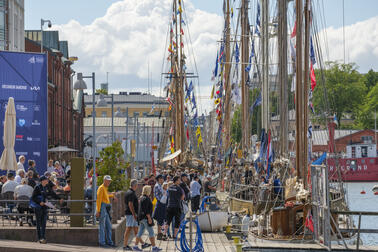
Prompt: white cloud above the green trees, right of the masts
<box><xmin>321</xmin><ymin>16</ymin><xmax>378</xmax><ymax>72</ymax></box>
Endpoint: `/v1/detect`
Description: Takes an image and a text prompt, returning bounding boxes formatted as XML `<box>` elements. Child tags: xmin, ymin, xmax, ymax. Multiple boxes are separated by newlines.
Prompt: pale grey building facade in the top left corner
<box><xmin>0</xmin><ymin>0</ymin><xmax>25</xmax><ymax>52</ymax></box>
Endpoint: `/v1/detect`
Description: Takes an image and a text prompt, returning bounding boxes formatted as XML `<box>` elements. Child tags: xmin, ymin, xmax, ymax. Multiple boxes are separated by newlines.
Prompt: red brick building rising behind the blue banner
<box><xmin>25</xmin><ymin>31</ymin><xmax>84</xmax><ymax>156</ymax></box>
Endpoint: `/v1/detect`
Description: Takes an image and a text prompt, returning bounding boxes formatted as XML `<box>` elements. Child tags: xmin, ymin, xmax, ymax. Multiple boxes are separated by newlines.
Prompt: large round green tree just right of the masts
<box><xmin>313</xmin><ymin>62</ymin><xmax>366</xmax><ymax>127</ymax></box>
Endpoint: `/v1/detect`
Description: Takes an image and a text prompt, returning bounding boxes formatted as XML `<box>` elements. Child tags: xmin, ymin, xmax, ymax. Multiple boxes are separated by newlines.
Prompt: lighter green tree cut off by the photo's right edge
<box><xmin>357</xmin><ymin>83</ymin><xmax>378</xmax><ymax>129</ymax></box>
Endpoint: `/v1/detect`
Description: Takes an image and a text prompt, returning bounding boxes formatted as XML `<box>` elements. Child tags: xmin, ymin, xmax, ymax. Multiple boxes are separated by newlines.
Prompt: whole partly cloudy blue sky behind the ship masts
<box><xmin>25</xmin><ymin>0</ymin><xmax>378</xmax><ymax>113</ymax></box>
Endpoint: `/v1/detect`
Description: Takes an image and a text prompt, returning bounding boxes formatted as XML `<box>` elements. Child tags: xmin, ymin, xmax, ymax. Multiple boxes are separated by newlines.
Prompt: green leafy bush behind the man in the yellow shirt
<box><xmin>97</xmin><ymin>141</ymin><xmax>130</xmax><ymax>191</ymax></box>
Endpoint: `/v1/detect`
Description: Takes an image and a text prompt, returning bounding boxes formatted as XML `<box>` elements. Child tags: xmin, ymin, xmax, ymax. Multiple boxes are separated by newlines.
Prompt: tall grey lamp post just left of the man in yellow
<box><xmin>74</xmin><ymin>73</ymin><xmax>97</xmax><ymax>225</ymax></box>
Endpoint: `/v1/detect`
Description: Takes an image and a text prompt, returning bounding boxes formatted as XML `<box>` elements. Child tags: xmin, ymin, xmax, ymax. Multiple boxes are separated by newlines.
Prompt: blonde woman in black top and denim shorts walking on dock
<box><xmin>133</xmin><ymin>185</ymin><xmax>162</xmax><ymax>252</ymax></box>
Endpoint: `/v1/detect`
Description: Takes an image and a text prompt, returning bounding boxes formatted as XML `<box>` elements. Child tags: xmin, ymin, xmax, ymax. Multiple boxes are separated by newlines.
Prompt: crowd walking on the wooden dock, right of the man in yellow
<box><xmin>119</xmin><ymin>169</ymin><xmax>216</xmax><ymax>251</ymax></box>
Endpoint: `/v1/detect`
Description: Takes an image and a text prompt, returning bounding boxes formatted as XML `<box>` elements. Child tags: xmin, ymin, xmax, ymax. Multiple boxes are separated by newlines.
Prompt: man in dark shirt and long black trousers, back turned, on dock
<box><xmin>166</xmin><ymin>176</ymin><xmax>185</xmax><ymax>239</ymax></box>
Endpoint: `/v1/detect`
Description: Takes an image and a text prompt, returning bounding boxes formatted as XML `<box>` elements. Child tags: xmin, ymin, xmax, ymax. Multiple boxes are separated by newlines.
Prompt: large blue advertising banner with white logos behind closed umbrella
<box><xmin>0</xmin><ymin>51</ymin><xmax>48</xmax><ymax>175</ymax></box>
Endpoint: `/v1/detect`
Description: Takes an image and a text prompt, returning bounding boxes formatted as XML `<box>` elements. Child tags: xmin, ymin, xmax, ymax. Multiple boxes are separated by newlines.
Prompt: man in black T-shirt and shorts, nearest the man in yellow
<box><xmin>123</xmin><ymin>179</ymin><xmax>150</xmax><ymax>251</ymax></box>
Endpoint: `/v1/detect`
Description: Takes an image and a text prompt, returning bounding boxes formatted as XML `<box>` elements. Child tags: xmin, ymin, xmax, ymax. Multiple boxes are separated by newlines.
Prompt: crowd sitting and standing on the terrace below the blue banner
<box><xmin>0</xmin><ymin>155</ymin><xmax>71</xmax><ymax>243</ymax></box>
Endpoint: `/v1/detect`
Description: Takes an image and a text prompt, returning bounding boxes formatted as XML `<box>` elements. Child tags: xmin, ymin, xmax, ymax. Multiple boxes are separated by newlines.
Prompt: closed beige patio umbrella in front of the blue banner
<box><xmin>0</xmin><ymin>97</ymin><xmax>17</xmax><ymax>171</ymax></box>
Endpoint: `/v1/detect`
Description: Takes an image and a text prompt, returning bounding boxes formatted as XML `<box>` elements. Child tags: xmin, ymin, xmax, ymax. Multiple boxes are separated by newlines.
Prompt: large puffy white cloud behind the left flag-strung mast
<box><xmin>53</xmin><ymin>0</ymin><xmax>223</xmax><ymax>88</ymax></box>
